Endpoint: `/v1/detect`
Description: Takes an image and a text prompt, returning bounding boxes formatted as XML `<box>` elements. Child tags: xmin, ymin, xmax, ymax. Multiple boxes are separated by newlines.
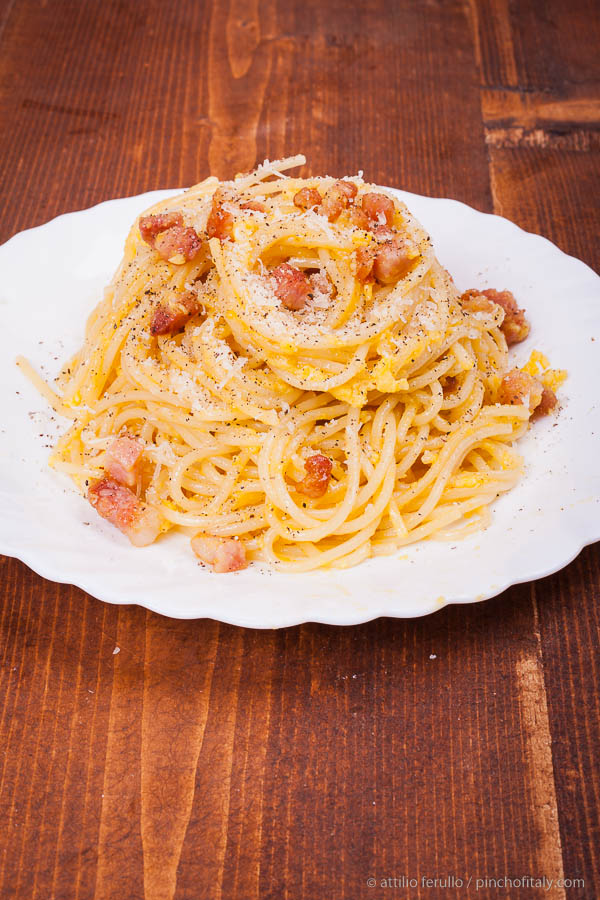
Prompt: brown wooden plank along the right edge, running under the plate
<box><xmin>482</xmin><ymin>7</ymin><xmax>600</xmax><ymax>897</ymax></box>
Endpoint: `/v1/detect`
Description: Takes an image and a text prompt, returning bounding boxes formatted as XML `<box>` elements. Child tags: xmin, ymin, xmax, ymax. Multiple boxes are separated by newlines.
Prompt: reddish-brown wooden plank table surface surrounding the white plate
<box><xmin>0</xmin><ymin>0</ymin><xmax>600</xmax><ymax>900</ymax></box>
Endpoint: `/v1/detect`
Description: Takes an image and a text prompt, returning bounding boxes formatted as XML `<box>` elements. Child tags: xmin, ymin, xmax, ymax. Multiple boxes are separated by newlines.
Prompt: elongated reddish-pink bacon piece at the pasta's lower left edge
<box><xmin>88</xmin><ymin>477</ymin><xmax>162</xmax><ymax>547</ymax></box>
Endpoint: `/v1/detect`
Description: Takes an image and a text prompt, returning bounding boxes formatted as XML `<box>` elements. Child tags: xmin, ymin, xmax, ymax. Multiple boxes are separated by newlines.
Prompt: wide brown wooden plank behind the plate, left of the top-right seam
<box><xmin>0</xmin><ymin>0</ymin><xmax>491</xmax><ymax>250</ymax></box>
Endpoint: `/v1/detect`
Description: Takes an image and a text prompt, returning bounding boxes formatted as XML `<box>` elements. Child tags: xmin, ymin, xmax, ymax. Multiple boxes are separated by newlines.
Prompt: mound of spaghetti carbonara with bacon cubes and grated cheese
<box><xmin>20</xmin><ymin>156</ymin><xmax>561</xmax><ymax>572</ymax></box>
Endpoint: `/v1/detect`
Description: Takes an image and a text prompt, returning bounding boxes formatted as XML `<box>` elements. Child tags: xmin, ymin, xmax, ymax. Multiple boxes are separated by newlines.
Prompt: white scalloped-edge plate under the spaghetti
<box><xmin>0</xmin><ymin>191</ymin><xmax>600</xmax><ymax>628</ymax></box>
